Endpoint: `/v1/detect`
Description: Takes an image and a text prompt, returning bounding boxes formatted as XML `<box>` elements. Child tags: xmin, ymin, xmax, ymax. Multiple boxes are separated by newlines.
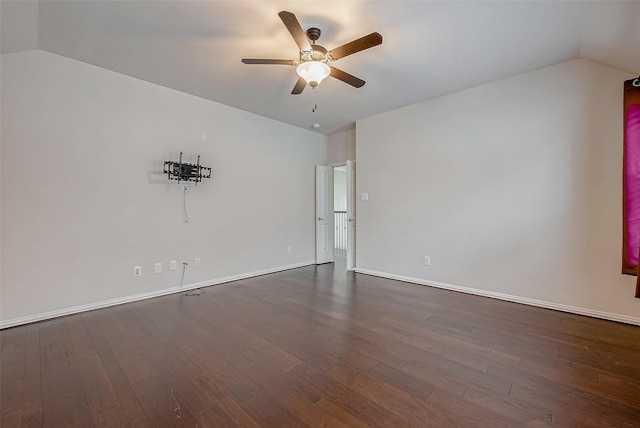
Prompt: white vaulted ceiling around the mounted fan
<box><xmin>0</xmin><ymin>0</ymin><xmax>640</xmax><ymax>134</ymax></box>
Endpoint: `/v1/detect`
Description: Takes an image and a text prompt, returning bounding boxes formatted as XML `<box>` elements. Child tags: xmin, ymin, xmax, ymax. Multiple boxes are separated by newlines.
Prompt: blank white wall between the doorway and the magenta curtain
<box><xmin>356</xmin><ymin>60</ymin><xmax>640</xmax><ymax>323</ymax></box>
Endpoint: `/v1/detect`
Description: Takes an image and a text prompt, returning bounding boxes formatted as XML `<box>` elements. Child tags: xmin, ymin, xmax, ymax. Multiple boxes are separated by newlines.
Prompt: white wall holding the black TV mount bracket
<box><xmin>1</xmin><ymin>51</ymin><xmax>327</xmax><ymax>326</ymax></box>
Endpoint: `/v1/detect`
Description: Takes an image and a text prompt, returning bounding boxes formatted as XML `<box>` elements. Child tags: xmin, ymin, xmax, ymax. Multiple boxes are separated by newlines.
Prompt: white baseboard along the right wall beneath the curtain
<box><xmin>355</xmin><ymin>268</ymin><xmax>640</xmax><ymax>325</ymax></box>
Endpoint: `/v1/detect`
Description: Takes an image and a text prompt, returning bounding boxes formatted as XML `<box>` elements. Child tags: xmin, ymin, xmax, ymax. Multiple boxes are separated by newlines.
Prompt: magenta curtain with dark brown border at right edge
<box><xmin>622</xmin><ymin>77</ymin><xmax>640</xmax><ymax>298</ymax></box>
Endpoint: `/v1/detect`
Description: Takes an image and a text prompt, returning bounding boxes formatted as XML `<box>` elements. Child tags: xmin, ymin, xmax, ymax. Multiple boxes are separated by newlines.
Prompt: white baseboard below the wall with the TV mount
<box><xmin>0</xmin><ymin>260</ymin><xmax>315</xmax><ymax>330</ymax></box>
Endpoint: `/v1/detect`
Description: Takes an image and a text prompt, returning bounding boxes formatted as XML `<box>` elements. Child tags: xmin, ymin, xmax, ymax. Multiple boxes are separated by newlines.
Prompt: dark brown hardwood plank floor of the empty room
<box><xmin>0</xmin><ymin>264</ymin><xmax>640</xmax><ymax>428</ymax></box>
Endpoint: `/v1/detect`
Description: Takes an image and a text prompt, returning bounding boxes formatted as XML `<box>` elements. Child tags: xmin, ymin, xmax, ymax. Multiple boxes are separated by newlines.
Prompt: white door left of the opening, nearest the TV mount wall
<box><xmin>316</xmin><ymin>165</ymin><xmax>334</xmax><ymax>264</ymax></box>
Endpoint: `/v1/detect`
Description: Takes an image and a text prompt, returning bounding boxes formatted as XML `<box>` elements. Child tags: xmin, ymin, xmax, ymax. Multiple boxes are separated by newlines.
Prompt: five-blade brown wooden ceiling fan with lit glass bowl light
<box><xmin>242</xmin><ymin>11</ymin><xmax>382</xmax><ymax>95</ymax></box>
